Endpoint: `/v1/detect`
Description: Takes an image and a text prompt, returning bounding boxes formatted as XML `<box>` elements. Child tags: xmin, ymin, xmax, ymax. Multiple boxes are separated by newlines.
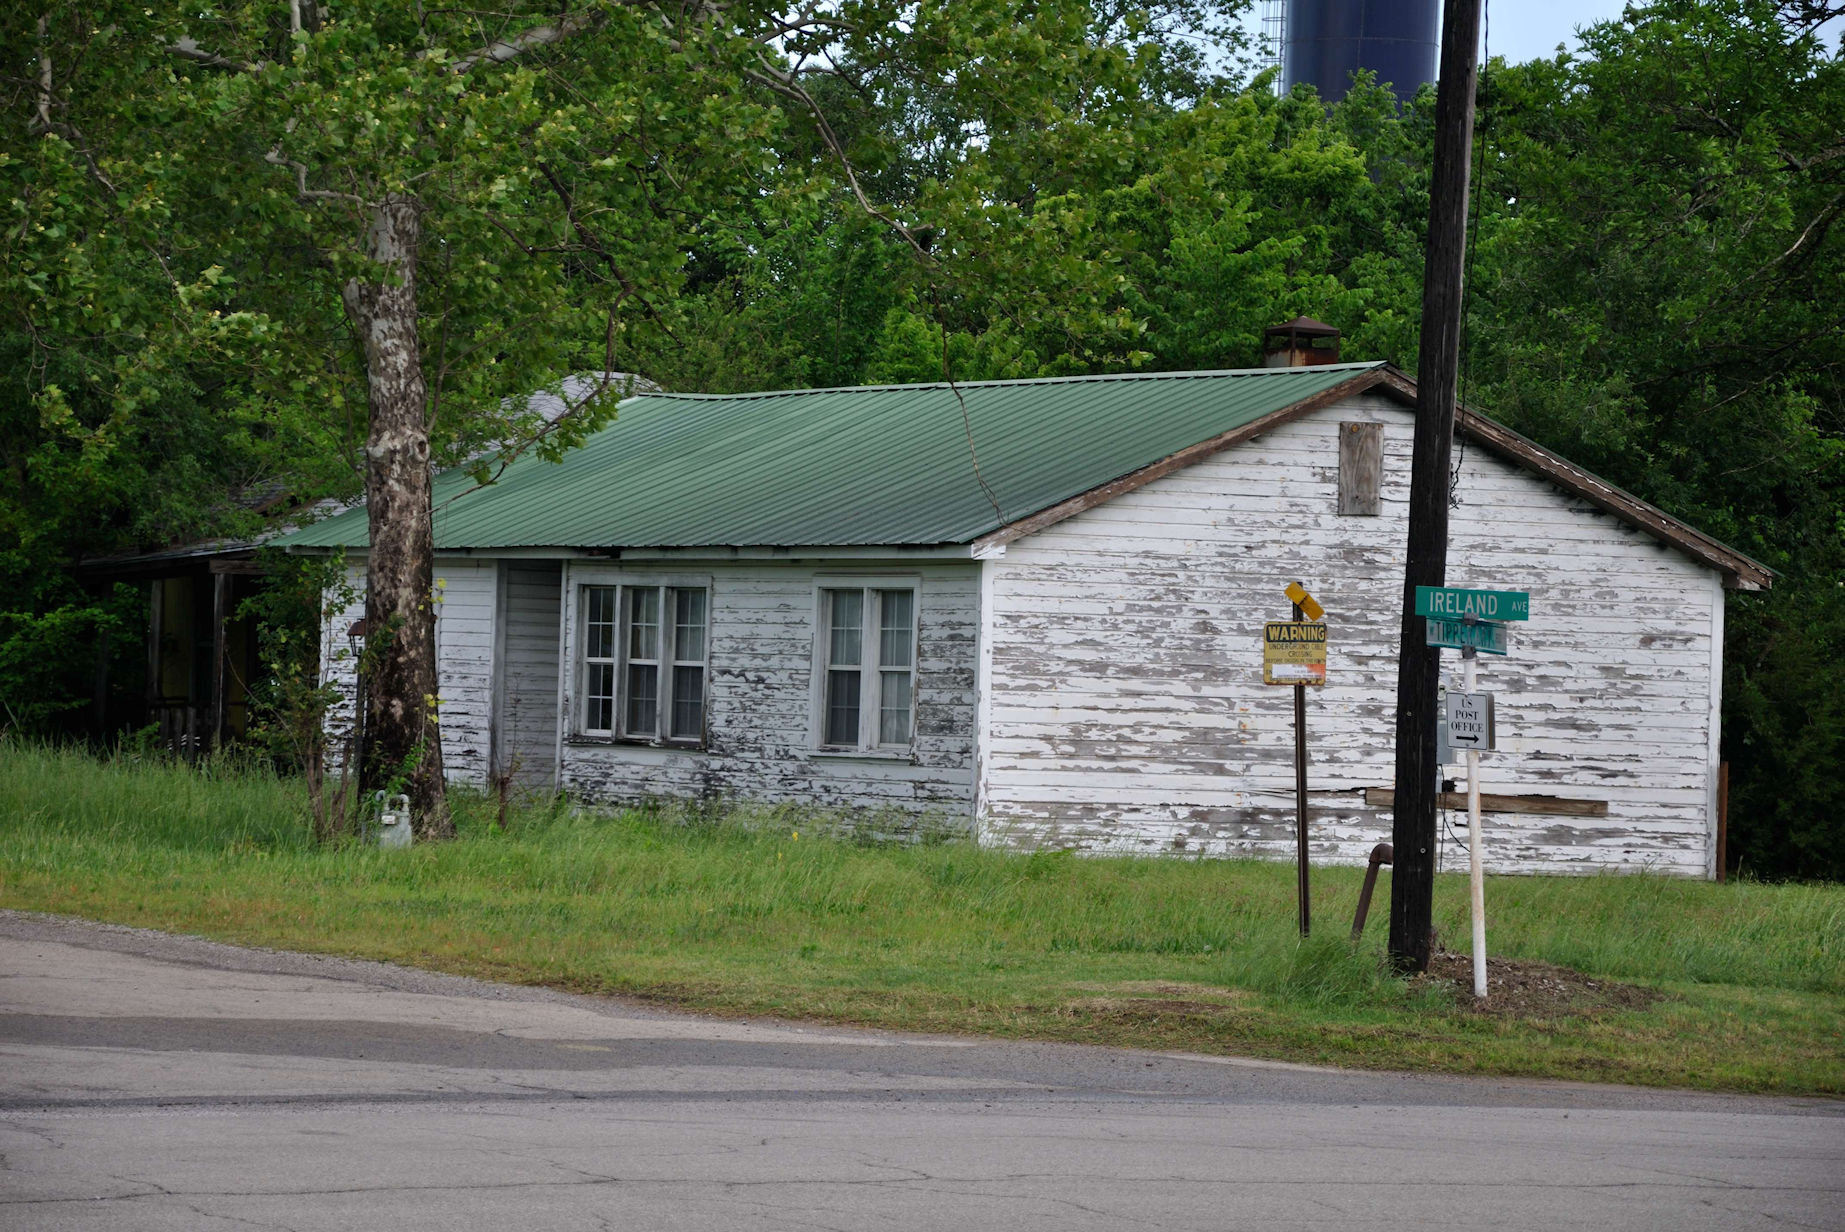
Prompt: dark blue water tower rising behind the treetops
<box><xmin>1282</xmin><ymin>0</ymin><xmax>1441</xmax><ymax>103</ymax></box>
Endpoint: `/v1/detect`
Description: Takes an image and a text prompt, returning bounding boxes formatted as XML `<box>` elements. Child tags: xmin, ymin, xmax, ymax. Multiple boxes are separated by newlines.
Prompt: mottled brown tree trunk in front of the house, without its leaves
<box><xmin>345</xmin><ymin>195</ymin><xmax>454</xmax><ymax>839</ymax></box>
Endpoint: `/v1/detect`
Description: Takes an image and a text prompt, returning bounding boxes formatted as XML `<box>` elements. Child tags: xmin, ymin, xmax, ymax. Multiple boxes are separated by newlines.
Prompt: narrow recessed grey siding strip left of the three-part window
<box><xmin>494</xmin><ymin>561</ymin><xmax>565</xmax><ymax>791</ymax></box>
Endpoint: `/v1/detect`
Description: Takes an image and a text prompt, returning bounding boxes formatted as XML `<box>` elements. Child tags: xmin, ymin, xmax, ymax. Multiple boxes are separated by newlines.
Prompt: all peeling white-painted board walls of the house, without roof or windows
<box><xmin>323</xmin><ymin>395</ymin><xmax>1723</xmax><ymax>876</ymax></box>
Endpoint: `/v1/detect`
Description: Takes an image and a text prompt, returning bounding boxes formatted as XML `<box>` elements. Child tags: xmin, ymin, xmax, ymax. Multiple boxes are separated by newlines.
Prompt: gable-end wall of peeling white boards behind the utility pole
<box><xmin>982</xmin><ymin>395</ymin><xmax>1721</xmax><ymax>874</ymax></box>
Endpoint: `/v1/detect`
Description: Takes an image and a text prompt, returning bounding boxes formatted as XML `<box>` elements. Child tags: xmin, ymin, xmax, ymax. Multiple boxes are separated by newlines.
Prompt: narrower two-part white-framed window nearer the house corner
<box><xmin>817</xmin><ymin>585</ymin><xmax>917</xmax><ymax>751</ymax></box>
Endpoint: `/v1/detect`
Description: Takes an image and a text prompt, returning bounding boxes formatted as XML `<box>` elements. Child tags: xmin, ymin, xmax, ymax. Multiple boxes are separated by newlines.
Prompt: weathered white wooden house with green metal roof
<box><xmin>292</xmin><ymin>355</ymin><xmax>1771</xmax><ymax>876</ymax></box>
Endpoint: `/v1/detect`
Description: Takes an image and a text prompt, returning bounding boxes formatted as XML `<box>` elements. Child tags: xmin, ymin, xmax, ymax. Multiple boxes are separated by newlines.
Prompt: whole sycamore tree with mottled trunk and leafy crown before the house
<box><xmin>0</xmin><ymin>0</ymin><xmax>1240</xmax><ymax>837</ymax></box>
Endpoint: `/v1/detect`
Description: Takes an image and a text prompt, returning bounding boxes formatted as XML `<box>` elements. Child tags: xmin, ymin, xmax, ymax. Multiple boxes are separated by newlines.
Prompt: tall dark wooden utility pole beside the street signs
<box><xmin>1389</xmin><ymin>0</ymin><xmax>1480</xmax><ymax>972</ymax></box>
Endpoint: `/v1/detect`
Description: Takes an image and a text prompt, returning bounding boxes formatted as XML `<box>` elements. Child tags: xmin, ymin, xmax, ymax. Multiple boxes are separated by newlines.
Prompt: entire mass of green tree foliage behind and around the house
<box><xmin>0</xmin><ymin>0</ymin><xmax>1845</xmax><ymax>878</ymax></box>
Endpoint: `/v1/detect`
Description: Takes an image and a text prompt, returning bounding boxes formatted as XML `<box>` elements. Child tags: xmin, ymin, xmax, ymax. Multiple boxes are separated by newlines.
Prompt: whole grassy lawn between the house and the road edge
<box><xmin>0</xmin><ymin>743</ymin><xmax>1845</xmax><ymax>1094</ymax></box>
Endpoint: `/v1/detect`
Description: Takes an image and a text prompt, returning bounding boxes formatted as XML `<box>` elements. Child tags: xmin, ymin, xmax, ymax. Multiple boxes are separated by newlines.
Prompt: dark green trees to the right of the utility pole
<box><xmin>1461</xmin><ymin>0</ymin><xmax>1845</xmax><ymax>878</ymax></box>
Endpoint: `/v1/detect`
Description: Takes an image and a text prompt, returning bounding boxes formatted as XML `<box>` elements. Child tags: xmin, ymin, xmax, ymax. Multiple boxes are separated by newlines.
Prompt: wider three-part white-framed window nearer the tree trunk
<box><xmin>577</xmin><ymin>585</ymin><xmax>710</xmax><ymax>745</ymax></box>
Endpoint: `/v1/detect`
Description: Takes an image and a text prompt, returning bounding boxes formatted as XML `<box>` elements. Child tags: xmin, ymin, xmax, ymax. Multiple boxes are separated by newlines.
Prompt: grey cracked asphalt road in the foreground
<box><xmin>0</xmin><ymin>913</ymin><xmax>1845</xmax><ymax>1232</ymax></box>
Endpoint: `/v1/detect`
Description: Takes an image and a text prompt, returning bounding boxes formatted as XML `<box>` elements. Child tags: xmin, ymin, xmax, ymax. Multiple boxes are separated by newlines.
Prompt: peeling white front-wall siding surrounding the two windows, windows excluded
<box><xmin>561</xmin><ymin>563</ymin><xmax>978</xmax><ymax>819</ymax></box>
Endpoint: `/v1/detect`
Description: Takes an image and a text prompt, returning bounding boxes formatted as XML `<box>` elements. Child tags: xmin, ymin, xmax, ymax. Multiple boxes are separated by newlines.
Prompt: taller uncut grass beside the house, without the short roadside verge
<box><xmin>0</xmin><ymin>741</ymin><xmax>1845</xmax><ymax>1005</ymax></box>
